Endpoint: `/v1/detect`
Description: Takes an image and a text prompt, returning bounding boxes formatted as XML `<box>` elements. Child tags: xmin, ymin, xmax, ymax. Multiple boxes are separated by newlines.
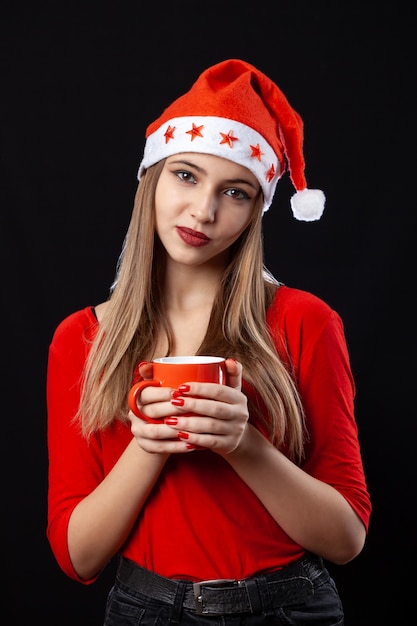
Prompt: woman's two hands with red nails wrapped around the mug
<box><xmin>129</xmin><ymin>359</ymin><xmax>249</xmax><ymax>455</ymax></box>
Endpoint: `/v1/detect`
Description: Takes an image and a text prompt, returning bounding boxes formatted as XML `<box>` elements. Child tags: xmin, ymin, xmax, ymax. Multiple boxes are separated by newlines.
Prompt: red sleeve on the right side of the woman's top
<box><xmin>268</xmin><ymin>286</ymin><xmax>371</xmax><ymax>529</ymax></box>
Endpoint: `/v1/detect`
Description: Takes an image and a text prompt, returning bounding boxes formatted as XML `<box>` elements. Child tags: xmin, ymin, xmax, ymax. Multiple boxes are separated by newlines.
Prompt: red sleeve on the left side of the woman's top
<box><xmin>47</xmin><ymin>308</ymin><xmax>103</xmax><ymax>583</ymax></box>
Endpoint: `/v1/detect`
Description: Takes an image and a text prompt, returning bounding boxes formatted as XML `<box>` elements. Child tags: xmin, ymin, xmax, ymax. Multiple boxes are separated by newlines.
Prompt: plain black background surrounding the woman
<box><xmin>0</xmin><ymin>0</ymin><xmax>416</xmax><ymax>626</ymax></box>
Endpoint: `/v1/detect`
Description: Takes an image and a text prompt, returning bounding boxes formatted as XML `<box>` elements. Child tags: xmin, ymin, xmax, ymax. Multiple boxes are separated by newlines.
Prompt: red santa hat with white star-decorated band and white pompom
<box><xmin>138</xmin><ymin>59</ymin><xmax>325</xmax><ymax>222</ymax></box>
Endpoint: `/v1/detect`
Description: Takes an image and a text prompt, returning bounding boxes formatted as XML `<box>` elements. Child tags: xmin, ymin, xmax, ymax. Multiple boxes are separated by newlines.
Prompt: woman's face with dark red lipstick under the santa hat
<box><xmin>155</xmin><ymin>152</ymin><xmax>260</xmax><ymax>266</ymax></box>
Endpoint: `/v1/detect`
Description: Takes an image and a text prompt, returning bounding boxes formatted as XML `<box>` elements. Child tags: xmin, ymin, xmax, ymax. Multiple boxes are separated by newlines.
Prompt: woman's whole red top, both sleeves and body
<box><xmin>47</xmin><ymin>286</ymin><xmax>371</xmax><ymax>584</ymax></box>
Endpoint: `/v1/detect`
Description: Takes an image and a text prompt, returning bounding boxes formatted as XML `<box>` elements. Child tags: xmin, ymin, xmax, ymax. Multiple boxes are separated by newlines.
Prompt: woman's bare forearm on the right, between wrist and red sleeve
<box><xmin>225</xmin><ymin>425</ymin><xmax>366</xmax><ymax>564</ymax></box>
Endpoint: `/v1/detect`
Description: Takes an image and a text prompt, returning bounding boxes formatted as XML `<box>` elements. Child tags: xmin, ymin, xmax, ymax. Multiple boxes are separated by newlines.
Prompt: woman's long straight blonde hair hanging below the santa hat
<box><xmin>76</xmin><ymin>161</ymin><xmax>305</xmax><ymax>461</ymax></box>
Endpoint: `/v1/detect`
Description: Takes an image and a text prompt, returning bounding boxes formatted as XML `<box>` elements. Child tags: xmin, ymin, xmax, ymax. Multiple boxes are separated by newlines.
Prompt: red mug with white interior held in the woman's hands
<box><xmin>128</xmin><ymin>356</ymin><xmax>226</xmax><ymax>423</ymax></box>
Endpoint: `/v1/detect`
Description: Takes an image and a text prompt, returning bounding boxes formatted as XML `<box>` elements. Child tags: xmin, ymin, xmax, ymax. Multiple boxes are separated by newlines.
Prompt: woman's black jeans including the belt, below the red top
<box><xmin>104</xmin><ymin>554</ymin><xmax>344</xmax><ymax>626</ymax></box>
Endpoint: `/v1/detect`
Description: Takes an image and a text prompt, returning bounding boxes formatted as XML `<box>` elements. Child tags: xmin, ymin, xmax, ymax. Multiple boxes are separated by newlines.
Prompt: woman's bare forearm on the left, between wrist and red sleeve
<box><xmin>68</xmin><ymin>439</ymin><xmax>168</xmax><ymax>580</ymax></box>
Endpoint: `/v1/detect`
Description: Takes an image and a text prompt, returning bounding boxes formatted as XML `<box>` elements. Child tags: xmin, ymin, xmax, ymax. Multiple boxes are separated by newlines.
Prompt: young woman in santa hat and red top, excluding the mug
<box><xmin>47</xmin><ymin>59</ymin><xmax>371</xmax><ymax>626</ymax></box>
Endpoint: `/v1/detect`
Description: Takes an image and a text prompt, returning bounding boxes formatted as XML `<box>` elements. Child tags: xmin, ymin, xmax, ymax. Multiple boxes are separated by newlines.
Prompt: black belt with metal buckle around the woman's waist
<box><xmin>116</xmin><ymin>553</ymin><xmax>329</xmax><ymax>615</ymax></box>
